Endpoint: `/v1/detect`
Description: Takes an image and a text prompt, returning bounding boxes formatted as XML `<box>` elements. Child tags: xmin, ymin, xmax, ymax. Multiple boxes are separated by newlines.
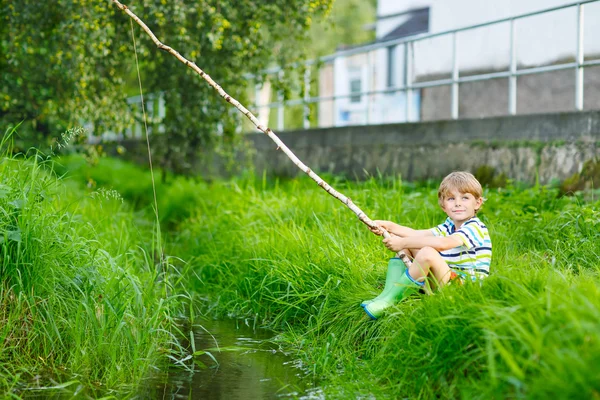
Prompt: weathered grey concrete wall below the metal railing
<box><xmin>247</xmin><ymin>111</ymin><xmax>600</xmax><ymax>183</ymax></box>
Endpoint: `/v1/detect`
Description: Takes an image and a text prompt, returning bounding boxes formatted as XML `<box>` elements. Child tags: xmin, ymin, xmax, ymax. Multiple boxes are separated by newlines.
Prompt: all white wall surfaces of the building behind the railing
<box><xmin>319</xmin><ymin>0</ymin><xmax>600</xmax><ymax>126</ymax></box>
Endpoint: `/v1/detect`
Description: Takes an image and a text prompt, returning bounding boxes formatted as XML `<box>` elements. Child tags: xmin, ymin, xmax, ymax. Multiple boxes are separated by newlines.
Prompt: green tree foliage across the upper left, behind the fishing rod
<box><xmin>0</xmin><ymin>0</ymin><xmax>333</xmax><ymax>172</ymax></box>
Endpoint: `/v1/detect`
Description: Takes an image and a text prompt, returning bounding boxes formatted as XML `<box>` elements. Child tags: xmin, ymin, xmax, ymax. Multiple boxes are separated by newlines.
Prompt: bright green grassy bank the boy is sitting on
<box><xmin>50</xmin><ymin>155</ymin><xmax>600</xmax><ymax>398</ymax></box>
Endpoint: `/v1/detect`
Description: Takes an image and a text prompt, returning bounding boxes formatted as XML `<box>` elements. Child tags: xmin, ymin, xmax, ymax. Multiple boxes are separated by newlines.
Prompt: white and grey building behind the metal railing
<box><xmin>316</xmin><ymin>0</ymin><xmax>600</xmax><ymax>127</ymax></box>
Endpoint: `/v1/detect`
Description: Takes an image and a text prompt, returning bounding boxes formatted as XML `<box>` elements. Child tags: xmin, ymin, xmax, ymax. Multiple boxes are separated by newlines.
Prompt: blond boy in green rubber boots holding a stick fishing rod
<box><xmin>361</xmin><ymin>171</ymin><xmax>492</xmax><ymax>319</ymax></box>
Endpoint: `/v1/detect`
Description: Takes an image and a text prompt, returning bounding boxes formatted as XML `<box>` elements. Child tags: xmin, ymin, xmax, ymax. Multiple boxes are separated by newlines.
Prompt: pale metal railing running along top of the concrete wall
<box><xmin>253</xmin><ymin>0</ymin><xmax>600</xmax><ymax>131</ymax></box>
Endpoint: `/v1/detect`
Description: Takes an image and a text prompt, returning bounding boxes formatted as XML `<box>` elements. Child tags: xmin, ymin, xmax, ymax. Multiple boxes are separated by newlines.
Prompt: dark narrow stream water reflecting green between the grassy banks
<box><xmin>138</xmin><ymin>320</ymin><xmax>321</xmax><ymax>400</ymax></box>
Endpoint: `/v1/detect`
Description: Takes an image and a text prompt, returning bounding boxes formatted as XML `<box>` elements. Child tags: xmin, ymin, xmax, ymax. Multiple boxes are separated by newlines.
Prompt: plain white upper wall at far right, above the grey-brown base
<box><xmin>377</xmin><ymin>0</ymin><xmax>600</xmax><ymax>78</ymax></box>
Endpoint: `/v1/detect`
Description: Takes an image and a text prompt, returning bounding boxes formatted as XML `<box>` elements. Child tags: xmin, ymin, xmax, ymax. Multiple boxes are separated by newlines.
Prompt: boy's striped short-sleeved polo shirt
<box><xmin>431</xmin><ymin>217</ymin><xmax>492</xmax><ymax>280</ymax></box>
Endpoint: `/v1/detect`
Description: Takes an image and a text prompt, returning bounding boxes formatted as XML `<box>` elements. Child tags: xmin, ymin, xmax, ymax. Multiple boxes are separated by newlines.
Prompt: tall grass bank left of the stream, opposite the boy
<box><xmin>0</xmin><ymin>153</ymin><xmax>184</xmax><ymax>398</ymax></box>
